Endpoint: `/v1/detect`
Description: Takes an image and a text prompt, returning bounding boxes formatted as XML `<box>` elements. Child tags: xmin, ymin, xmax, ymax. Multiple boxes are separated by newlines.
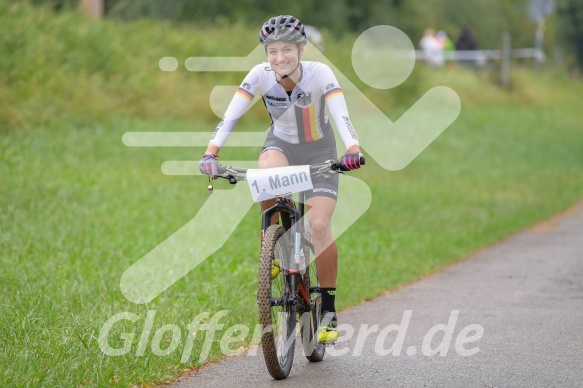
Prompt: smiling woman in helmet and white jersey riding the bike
<box><xmin>199</xmin><ymin>15</ymin><xmax>362</xmax><ymax>344</ymax></box>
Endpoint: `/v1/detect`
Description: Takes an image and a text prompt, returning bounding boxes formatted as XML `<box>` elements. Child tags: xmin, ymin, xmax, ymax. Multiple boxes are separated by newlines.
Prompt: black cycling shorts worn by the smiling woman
<box><xmin>260</xmin><ymin>130</ymin><xmax>338</xmax><ymax>200</ymax></box>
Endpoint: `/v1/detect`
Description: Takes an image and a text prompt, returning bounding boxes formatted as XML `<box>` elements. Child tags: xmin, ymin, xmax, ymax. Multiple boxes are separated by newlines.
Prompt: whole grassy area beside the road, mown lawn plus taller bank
<box><xmin>0</xmin><ymin>0</ymin><xmax>583</xmax><ymax>387</ymax></box>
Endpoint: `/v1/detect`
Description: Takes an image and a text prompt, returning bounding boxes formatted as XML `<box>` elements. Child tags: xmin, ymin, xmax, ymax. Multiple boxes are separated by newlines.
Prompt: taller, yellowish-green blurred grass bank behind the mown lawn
<box><xmin>0</xmin><ymin>0</ymin><xmax>419</xmax><ymax>131</ymax></box>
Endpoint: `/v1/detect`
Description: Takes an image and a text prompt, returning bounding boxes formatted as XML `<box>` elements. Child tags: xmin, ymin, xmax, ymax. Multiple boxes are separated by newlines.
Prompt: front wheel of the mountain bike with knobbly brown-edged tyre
<box><xmin>257</xmin><ymin>225</ymin><xmax>297</xmax><ymax>379</ymax></box>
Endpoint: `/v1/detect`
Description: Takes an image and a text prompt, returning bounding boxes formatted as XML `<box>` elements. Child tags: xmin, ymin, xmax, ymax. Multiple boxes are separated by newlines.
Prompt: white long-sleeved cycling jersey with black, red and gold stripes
<box><xmin>210</xmin><ymin>61</ymin><xmax>359</xmax><ymax>148</ymax></box>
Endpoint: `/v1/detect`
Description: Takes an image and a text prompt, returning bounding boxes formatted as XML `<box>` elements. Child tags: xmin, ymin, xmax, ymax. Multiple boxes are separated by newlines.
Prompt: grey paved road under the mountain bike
<box><xmin>176</xmin><ymin>205</ymin><xmax>583</xmax><ymax>388</ymax></box>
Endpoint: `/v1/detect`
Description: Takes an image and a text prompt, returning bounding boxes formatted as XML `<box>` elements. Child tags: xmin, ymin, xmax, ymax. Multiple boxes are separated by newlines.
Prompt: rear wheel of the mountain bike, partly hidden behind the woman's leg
<box><xmin>300</xmin><ymin>220</ymin><xmax>326</xmax><ymax>362</ymax></box>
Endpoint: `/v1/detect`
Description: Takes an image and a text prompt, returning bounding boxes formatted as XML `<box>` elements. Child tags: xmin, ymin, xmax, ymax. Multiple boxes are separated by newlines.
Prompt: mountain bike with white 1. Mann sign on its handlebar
<box><xmin>209</xmin><ymin>158</ymin><xmax>364</xmax><ymax>380</ymax></box>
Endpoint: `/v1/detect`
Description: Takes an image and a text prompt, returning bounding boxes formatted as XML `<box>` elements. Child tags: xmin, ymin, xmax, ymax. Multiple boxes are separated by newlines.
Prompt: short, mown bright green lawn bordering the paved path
<box><xmin>0</xmin><ymin>96</ymin><xmax>583</xmax><ymax>386</ymax></box>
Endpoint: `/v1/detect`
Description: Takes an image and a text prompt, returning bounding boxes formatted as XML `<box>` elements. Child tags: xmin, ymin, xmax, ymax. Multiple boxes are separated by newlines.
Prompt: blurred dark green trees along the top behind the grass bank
<box><xmin>29</xmin><ymin>0</ymin><xmax>556</xmax><ymax>55</ymax></box>
